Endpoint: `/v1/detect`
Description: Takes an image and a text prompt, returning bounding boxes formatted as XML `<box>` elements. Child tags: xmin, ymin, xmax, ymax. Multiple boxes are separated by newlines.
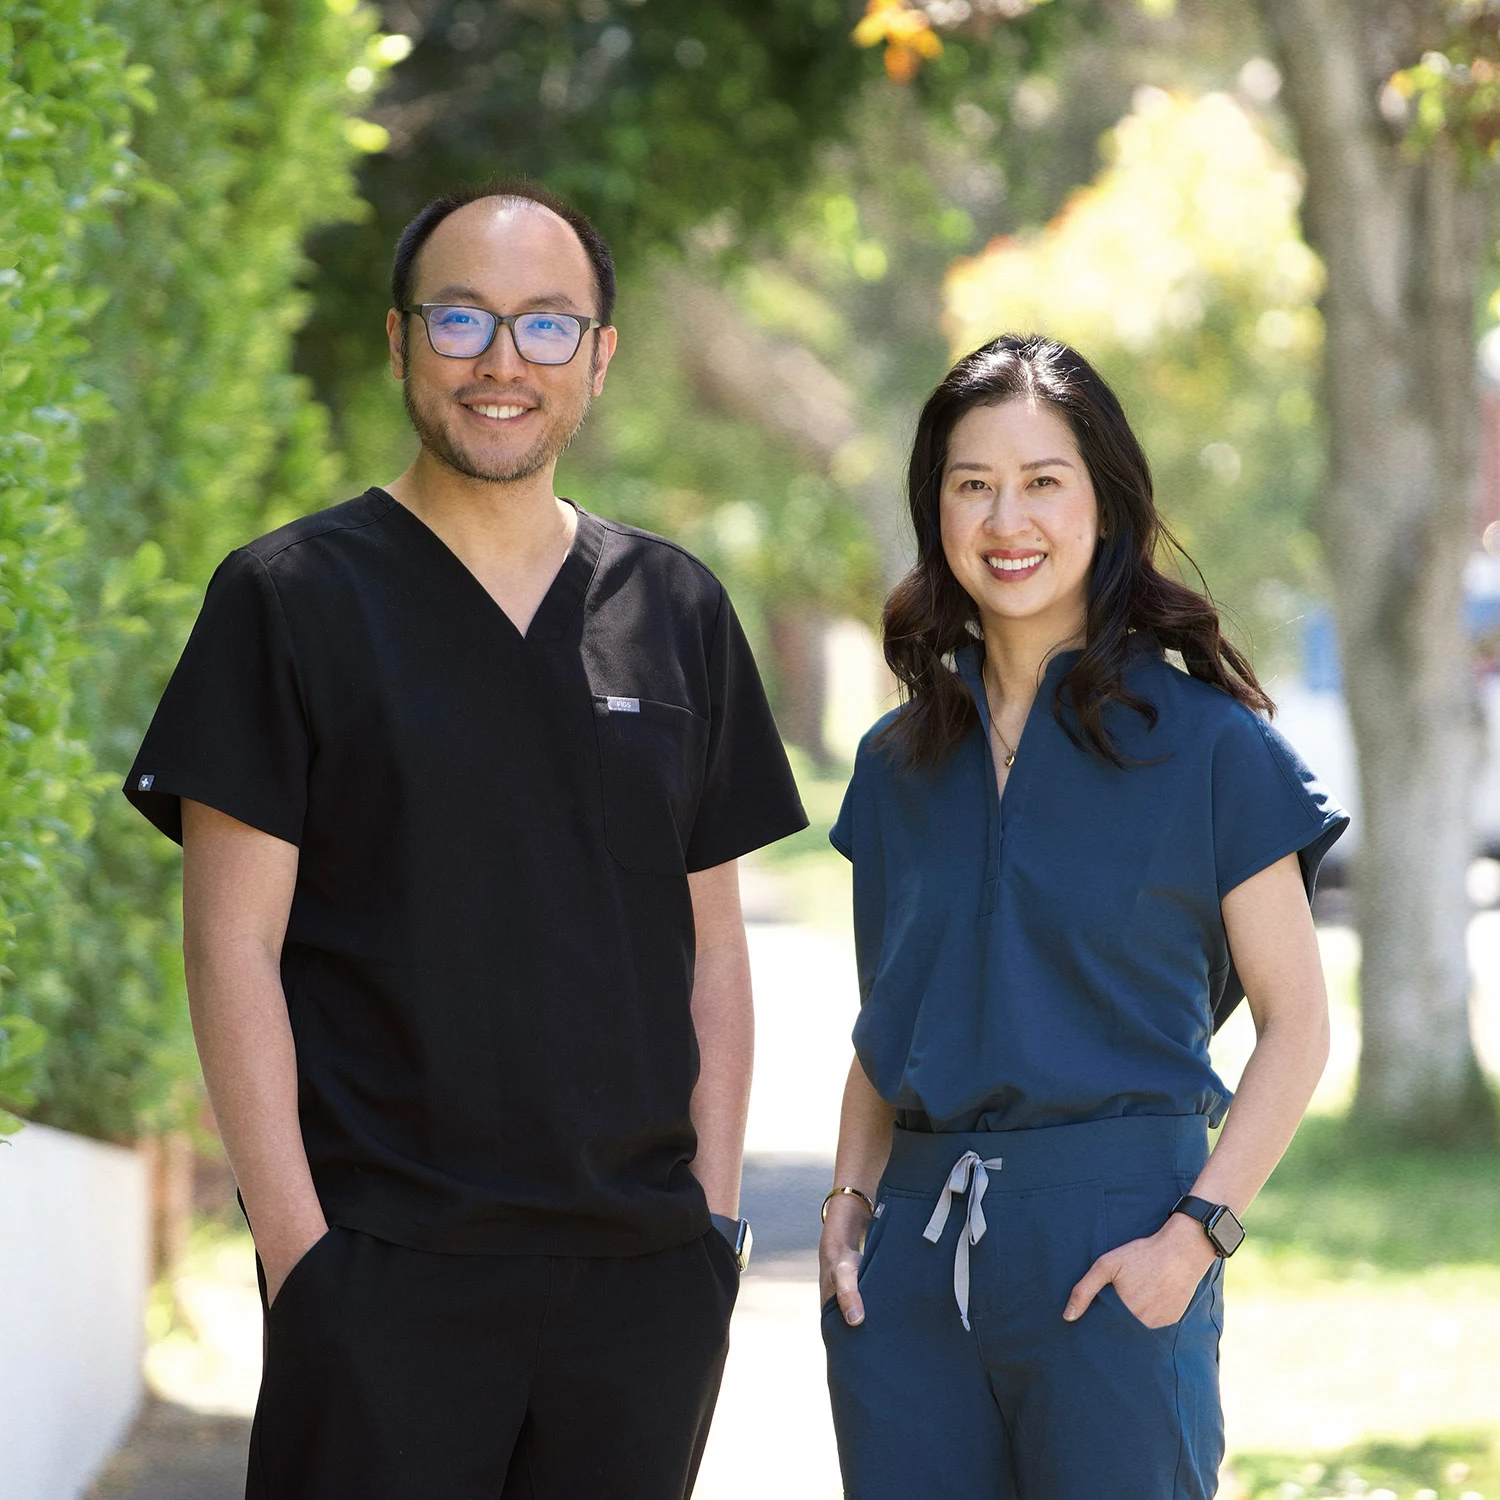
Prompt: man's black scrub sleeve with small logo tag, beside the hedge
<box><xmin>125</xmin><ymin>551</ymin><xmax>311</xmax><ymax>845</ymax></box>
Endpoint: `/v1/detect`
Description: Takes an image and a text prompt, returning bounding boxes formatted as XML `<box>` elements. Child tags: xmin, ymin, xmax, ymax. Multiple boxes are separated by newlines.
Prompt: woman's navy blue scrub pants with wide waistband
<box><xmin>822</xmin><ymin>1116</ymin><xmax>1224</xmax><ymax>1500</ymax></box>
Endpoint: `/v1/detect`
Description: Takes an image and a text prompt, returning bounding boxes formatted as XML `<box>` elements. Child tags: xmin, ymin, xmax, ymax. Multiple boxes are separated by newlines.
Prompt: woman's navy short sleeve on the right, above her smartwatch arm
<box><xmin>1214</xmin><ymin>711</ymin><xmax>1349</xmax><ymax>900</ymax></box>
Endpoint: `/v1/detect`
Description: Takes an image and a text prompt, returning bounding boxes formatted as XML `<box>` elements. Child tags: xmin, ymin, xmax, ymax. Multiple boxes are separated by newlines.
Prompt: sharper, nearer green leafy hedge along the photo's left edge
<box><xmin>0</xmin><ymin>0</ymin><xmax>141</xmax><ymax>1131</ymax></box>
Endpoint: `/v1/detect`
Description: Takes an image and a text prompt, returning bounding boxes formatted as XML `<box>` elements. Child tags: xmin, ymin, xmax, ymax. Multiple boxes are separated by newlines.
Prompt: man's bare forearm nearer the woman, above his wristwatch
<box><xmin>692</xmin><ymin>929</ymin><xmax>755</xmax><ymax>1217</ymax></box>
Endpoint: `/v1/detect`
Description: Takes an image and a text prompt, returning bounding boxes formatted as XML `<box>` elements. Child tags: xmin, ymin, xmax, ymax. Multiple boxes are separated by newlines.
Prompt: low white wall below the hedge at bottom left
<box><xmin>0</xmin><ymin>1125</ymin><xmax>149</xmax><ymax>1500</ymax></box>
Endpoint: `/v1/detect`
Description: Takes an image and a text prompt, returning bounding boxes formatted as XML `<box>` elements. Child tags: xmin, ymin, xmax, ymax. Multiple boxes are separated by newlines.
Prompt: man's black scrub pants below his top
<box><xmin>245</xmin><ymin>1229</ymin><xmax>738</xmax><ymax>1500</ymax></box>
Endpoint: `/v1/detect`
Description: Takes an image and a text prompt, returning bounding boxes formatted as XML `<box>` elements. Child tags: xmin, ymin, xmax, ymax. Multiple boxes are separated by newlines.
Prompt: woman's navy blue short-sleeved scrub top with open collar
<box><xmin>830</xmin><ymin>635</ymin><xmax>1349</xmax><ymax>1131</ymax></box>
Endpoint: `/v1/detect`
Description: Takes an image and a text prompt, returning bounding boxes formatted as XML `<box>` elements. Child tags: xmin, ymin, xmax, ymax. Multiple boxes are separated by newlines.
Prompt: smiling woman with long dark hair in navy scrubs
<box><xmin>821</xmin><ymin>338</ymin><xmax>1349</xmax><ymax>1500</ymax></box>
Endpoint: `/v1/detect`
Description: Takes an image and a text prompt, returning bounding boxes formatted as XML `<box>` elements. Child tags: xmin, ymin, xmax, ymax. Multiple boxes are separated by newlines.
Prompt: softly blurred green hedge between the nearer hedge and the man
<box><xmin>17</xmin><ymin>0</ymin><xmax>392</xmax><ymax>1137</ymax></box>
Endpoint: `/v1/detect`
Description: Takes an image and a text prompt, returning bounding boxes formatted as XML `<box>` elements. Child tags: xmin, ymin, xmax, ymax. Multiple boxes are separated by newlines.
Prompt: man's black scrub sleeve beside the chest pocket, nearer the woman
<box><xmin>687</xmin><ymin>591</ymin><xmax>807</xmax><ymax>872</ymax></box>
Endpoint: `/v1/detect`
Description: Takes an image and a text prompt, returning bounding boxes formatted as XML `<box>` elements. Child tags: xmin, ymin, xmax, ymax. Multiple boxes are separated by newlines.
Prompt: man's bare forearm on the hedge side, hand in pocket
<box><xmin>188</xmin><ymin>942</ymin><xmax>327</xmax><ymax>1272</ymax></box>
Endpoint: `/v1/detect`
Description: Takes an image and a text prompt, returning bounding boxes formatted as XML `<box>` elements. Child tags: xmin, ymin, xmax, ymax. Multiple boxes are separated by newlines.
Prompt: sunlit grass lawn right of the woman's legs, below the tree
<box><xmin>1224</xmin><ymin>1116</ymin><xmax>1500</xmax><ymax>1500</ymax></box>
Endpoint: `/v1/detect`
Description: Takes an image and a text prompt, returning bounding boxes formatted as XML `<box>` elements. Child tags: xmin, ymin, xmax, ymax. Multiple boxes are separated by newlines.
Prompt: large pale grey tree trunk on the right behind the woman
<box><xmin>1259</xmin><ymin>0</ymin><xmax>1496</xmax><ymax>1146</ymax></box>
